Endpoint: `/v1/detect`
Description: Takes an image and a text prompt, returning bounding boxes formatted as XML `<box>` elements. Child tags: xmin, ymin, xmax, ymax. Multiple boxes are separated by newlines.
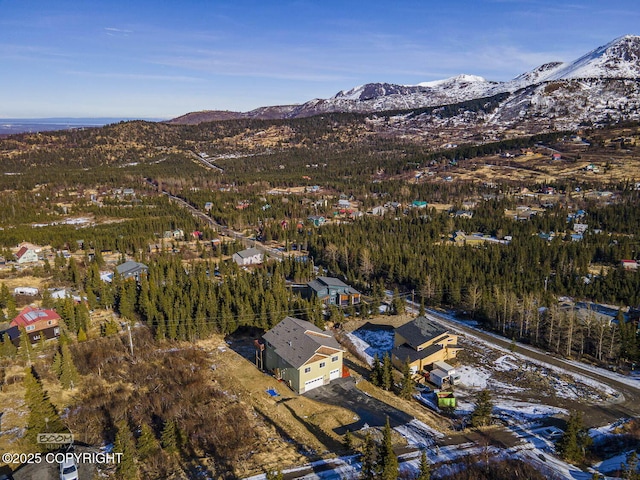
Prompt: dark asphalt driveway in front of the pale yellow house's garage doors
<box><xmin>304</xmin><ymin>377</ymin><xmax>413</xmax><ymax>435</ymax></box>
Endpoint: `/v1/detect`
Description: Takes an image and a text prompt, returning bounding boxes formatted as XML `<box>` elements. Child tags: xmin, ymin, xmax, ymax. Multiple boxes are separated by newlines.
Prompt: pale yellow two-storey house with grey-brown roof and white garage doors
<box><xmin>260</xmin><ymin>317</ymin><xmax>343</xmax><ymax>393</ymax></box>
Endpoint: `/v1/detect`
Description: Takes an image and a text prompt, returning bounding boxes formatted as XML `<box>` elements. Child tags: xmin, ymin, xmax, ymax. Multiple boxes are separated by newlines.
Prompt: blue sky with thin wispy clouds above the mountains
<box><xmin>0</xmin><ymin>0</ymin><xmax>640</xmax><ymax>118</ymax></box>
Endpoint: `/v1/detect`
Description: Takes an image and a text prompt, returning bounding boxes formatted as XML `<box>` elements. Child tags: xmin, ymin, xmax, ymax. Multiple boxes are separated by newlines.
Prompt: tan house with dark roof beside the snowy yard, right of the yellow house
<box><xmin>391</xmin><ymin>317</ymin><xmax>461</xmax><ymax>373</ymax></box>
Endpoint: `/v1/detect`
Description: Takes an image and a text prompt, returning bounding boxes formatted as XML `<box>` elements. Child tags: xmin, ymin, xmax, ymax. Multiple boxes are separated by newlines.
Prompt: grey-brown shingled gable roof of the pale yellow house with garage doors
<box><xmin>263</xmin><ymin>317</ymin><xmax>342</xmax><ymax>369</ymax></box>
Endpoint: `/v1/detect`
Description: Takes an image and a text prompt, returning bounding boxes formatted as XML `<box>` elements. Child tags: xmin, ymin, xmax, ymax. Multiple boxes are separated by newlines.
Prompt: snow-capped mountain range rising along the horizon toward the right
<box><xmin>169</xmin><ymin>35</ymin><xmax>640</xmax><ymax>132</ymax></box>
